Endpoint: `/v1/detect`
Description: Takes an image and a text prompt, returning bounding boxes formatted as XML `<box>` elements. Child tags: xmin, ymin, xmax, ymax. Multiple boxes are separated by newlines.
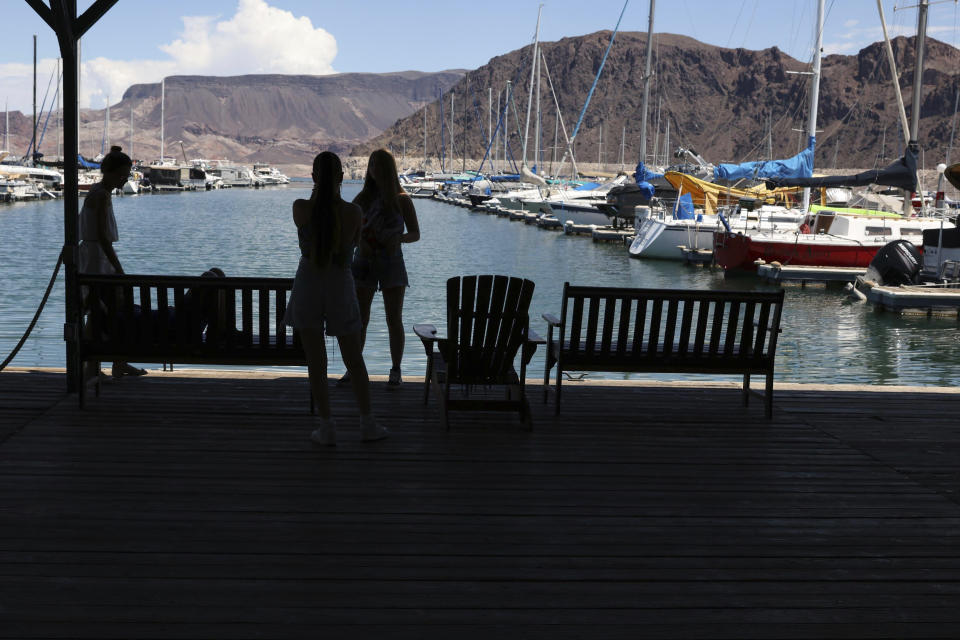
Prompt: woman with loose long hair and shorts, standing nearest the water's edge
<box><xmin>338</xmin><ymin>149</ymin><xmax>420</xmax><ymax>388</ymax></box>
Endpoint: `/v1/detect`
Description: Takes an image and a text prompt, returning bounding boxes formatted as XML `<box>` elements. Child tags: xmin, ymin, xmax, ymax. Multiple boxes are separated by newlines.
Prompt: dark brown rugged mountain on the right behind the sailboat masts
<box><xmin>354</xmin><ymin>31</ymin><xmax>960</xmax><ymax>169</ymax></box>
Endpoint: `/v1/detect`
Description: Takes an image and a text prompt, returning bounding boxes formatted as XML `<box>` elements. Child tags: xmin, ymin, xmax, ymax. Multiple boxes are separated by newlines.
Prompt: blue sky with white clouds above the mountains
<box><xmin>0</xmin><ymin>0</ymin><xmax>960</xmax><ymax>111</ymax></box>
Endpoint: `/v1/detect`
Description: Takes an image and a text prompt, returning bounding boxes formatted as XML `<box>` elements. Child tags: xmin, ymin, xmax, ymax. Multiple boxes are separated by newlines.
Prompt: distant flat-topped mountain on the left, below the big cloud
<box><xmin>0</xmin><ymin>70</ymin><xmax>463</xmax><ymax>163</ymax></box>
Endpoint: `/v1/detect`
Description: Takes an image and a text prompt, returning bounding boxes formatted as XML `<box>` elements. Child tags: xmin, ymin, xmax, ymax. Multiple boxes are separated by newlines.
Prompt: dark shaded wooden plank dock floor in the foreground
<box><xmin>0</xmin><ymin>372</ymin><xmax>960</xmax><ymax>640</ymax></box>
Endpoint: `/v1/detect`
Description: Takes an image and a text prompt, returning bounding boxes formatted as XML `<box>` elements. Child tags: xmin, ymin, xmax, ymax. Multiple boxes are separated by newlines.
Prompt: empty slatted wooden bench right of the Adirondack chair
<box><xmin>543</xmin><ymin>283</ymin><xmax>784</xmax><ymax>418</ymax></box>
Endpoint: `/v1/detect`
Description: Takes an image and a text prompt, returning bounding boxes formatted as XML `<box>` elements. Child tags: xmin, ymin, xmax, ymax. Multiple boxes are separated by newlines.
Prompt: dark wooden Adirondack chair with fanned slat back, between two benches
<box><xmin>413</xmin><ymin>275</ymin><xmax>545</xmax><ymax>430</ymax></box>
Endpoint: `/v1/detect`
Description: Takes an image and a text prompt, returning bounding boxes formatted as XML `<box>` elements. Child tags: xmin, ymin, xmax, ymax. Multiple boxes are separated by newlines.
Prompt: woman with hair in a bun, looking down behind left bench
<box><xmin>77</xmin><ymin>146</ymin><xmax>147</xmax><ymax>379</ymax></box>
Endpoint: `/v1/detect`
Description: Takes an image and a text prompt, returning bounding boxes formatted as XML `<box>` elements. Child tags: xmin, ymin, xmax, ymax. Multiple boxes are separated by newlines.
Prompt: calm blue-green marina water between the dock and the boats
<box><xmin>0</xmin><ymin>183</ymin><xmax>960</xmax><ymax>386</ymax></box>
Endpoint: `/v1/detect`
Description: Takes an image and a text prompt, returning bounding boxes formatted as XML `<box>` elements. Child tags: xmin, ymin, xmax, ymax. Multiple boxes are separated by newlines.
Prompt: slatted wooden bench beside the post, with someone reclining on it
<box><xmin>77</xmin><ymin>274</ymin><xmax>306</xmax><ymax>407</ymax></box>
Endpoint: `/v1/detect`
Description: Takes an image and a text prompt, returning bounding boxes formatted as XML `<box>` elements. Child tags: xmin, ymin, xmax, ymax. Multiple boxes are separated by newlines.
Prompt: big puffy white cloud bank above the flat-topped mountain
<box><xmin>0</xmin><ymin>0</ymin><xmax>337</xmax><ymax>112</ymax></box>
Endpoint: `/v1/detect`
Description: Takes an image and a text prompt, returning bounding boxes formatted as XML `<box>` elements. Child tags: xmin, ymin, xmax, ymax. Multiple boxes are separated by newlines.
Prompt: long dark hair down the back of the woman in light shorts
<box><xmin>310</xmin><ymin>151</ymin><xmax>346</xmax><ymax>267</ymax></box>
